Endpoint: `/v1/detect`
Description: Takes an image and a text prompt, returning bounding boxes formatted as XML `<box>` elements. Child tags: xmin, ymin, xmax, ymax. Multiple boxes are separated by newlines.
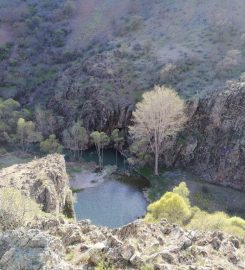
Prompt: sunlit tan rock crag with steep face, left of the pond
<box><xmin>0</xmin><ymin>154</ymin><xmax>73</xmax><ymax>216</ymax></box>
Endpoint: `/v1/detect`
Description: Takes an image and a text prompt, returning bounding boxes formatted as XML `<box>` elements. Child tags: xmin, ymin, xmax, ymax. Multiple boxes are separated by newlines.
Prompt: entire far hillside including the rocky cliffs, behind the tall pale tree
<box><xmin>0</xmin><ymin>0</ymin><xmax>245</xmax><ymax>190</ymax></box>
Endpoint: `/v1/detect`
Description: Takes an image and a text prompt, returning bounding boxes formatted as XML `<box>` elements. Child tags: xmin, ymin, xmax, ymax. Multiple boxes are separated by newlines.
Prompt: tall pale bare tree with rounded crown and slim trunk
<box><xmin>129</xmin><ymin>86</ymin><xmax>186</xmax><ymax>175</ymax></box>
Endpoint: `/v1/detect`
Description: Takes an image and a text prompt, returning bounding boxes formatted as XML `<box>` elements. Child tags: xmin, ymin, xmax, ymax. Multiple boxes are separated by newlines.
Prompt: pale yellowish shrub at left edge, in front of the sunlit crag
<box><xmin>0</xmin><ymin>188</ymin><xmax>43</xmax><ymax>230</ymax></box>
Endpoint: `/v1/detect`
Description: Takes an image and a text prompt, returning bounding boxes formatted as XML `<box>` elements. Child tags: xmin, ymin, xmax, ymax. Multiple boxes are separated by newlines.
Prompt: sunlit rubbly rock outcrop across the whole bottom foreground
<box><xmin>0</xmin><ymin>219</ymin><xmax>245</xmax><ymax>270</ymax></box>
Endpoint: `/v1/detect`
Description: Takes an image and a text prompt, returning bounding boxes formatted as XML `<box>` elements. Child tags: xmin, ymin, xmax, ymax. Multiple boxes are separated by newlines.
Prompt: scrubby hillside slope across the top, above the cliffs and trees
<box><xmin>0</xmin><ymin>0</ymin><xmax>245</xmax><ymax>119</ymax></box>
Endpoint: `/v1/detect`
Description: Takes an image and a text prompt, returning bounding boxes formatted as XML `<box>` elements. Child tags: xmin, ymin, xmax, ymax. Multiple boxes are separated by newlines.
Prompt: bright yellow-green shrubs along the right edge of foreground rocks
<box><xmin>145</xmin><ymin>182</ymin><xmax>245</xmax><ymax>237</ymax></box>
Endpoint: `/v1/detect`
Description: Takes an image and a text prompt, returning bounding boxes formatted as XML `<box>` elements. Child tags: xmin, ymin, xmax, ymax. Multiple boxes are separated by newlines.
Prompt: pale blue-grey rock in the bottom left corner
<box><xmin>0</xmin><ymin>229</ymin><xmax>74</xmax><ymax>270</ymax></box>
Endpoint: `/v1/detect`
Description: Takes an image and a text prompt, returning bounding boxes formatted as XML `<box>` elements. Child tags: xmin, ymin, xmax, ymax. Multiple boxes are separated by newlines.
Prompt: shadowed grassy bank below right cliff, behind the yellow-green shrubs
<box><xmin>137</xmin><ymin>167</ymin><xmax>245</xmax><ymax>219</ymax></box>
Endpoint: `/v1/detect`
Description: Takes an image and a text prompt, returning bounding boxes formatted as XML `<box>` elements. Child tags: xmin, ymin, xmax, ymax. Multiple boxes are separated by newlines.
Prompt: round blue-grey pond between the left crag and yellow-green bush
<box><xmin>75</xmin><ymin>175</ymin><xmax>147</xmax><ymax>228</ymax></box>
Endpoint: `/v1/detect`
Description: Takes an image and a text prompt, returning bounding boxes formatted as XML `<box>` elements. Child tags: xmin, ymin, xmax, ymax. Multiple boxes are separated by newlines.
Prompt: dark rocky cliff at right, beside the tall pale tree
<box><xmin>163</xmin><ymin>81</ymin><xmax>245</xmax><ymax>191</ymax></box>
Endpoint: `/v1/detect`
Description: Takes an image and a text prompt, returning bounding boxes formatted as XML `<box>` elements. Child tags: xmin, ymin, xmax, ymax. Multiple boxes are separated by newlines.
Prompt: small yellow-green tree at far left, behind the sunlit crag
<box><xmin>17</xmin><ymin>118</ymin><xmax>42</xmax><ymax>151</ymax></box>
